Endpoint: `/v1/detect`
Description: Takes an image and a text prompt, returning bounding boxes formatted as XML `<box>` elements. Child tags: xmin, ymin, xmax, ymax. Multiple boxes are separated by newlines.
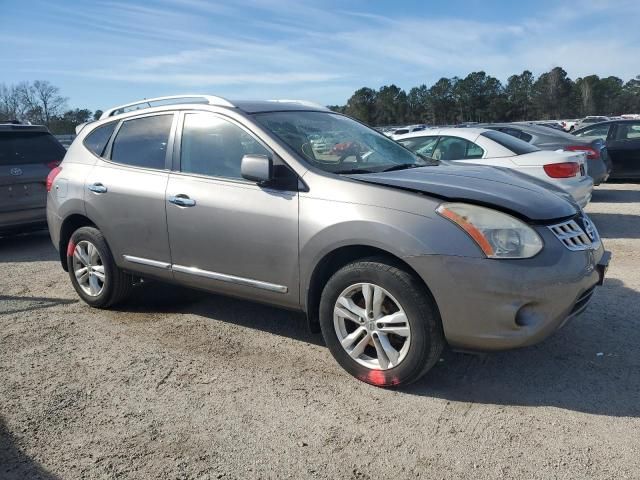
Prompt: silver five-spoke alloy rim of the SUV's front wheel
<box><xmin>333</xmin><ymin>283</ymin><xmax>411</xmax><ymax>370</ymax></box>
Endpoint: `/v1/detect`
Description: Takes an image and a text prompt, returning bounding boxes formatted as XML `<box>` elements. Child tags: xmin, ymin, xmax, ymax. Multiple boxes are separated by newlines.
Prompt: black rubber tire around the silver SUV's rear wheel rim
<box><xmin>67</xmin><ymin>227</ymin><xmax>133</xmax><ymax>308</ymax></box>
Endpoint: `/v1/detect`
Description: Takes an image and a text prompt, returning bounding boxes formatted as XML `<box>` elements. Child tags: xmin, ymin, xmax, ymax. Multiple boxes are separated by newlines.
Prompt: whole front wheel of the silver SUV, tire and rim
<box><xmin>320</xmin><ymin>258</ymin><xmax>444</xmax><ymax>387</ymax></box>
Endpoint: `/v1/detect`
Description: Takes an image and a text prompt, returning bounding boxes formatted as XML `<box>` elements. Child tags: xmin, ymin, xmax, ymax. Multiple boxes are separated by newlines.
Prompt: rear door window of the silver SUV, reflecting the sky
<box><xmin>111</xmin><ymin>114</ymin><xmax>173</xmax><ymax>170</ymax></box>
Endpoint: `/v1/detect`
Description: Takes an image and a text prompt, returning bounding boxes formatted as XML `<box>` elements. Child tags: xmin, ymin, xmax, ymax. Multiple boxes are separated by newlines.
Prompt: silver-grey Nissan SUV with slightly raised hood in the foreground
<box><xmin>47</xmin><ymin>96</ymin><xmax>609</xmax><ymax>386</ymax></box>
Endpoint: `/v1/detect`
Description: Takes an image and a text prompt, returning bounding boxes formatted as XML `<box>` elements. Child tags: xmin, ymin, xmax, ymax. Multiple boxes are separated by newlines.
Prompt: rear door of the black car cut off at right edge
<box><xmin>607</xmin><ymin>122</ymin><xmax>640</xmax><ymax>178</ymax></box>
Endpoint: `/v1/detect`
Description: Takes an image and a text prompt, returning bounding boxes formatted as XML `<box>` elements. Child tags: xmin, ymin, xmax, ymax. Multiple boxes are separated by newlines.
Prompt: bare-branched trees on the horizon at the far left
<box><xmin>0</xmin><ymin>80</ymin><xmax>102</xmax><ymax>134</ymax></box>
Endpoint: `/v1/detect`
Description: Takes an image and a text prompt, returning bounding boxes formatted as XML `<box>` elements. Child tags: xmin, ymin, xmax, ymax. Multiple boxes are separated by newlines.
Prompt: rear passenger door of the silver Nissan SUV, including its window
<box><xmin>85</xmin><ymin>112</ymin><xmax>176</xmax><ymax>278</ymax></box>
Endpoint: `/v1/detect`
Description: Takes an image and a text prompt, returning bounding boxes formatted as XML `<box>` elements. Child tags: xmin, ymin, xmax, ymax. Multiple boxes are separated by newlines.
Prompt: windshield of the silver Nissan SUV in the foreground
<box><xmin>254</xmin><ymin>111</ymin><xmax>437</xmax><ymax>173</ymax></box>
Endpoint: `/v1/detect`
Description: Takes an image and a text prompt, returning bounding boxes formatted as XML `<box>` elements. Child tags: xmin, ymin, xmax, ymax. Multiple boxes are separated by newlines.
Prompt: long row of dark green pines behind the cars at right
<box><xmin>329</xmin><ymin>67</ymin><xmax>640</xmax><ymax>126</ymax></box>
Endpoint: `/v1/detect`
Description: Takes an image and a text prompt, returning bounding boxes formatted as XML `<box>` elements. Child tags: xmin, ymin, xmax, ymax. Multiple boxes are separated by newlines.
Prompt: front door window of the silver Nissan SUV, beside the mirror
<box><xmin>180</xmin><ymin>113</ymin><xmax>270</xmax><ymax>179</ymax></box>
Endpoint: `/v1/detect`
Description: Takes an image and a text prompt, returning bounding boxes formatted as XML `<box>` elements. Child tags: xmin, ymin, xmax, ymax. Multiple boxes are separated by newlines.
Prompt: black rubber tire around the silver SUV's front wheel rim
<box><xmin>319</xmin><ymin>257</ymin><xmax>445</xmax><ymax>387</ymax></box>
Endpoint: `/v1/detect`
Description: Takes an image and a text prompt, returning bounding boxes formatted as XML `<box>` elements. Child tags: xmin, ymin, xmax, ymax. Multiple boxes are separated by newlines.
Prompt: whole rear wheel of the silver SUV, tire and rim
<box><xmin>67</xmin><ymin>227</ymin><xmax>133</xmax><ymax>308</ymax></box>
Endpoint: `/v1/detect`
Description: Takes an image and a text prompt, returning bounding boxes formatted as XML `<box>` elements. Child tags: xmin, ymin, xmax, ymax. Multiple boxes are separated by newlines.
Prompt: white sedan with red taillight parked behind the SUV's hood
<box><xmin>396</xmin><ymin>128</ymin><xmax>593</xmax><ymax>207</ymax></box>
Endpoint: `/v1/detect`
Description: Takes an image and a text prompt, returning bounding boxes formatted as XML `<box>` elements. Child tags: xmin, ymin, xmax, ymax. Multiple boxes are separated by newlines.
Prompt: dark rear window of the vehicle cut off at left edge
<box><xmin>0</xmin><ymin>131</ymin><xmax>66</xmax><ymax>165</ymax></box>
